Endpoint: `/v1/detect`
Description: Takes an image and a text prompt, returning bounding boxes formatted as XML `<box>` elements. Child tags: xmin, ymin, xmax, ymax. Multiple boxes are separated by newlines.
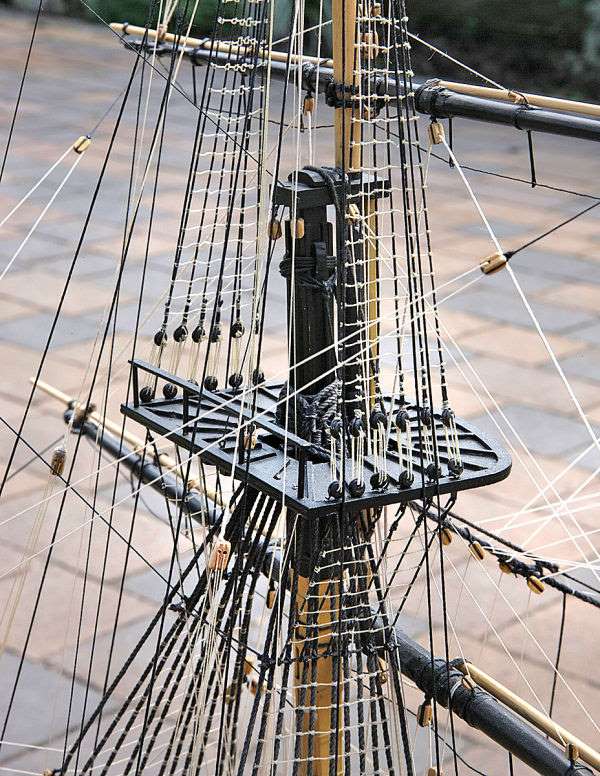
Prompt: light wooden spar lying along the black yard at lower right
<box><xmin>457</xmin><ymin>662</ymin><xmax>600</xmax><ymax>770</ymax></box>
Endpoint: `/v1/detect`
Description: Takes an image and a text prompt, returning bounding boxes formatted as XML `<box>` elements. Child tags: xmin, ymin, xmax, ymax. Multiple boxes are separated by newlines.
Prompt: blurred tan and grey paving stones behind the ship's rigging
<box><xmin>0</xmin><ymin>7</ymin><xmax>600</xmax><ymax>776</ymax></box>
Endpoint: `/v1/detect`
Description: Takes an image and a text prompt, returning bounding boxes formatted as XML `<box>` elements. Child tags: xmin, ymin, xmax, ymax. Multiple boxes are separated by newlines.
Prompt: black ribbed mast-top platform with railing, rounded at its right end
<box><xmin>121</xmin><ymin>361</ymin><xmax>511</xmax><ymax>518</ymax></box>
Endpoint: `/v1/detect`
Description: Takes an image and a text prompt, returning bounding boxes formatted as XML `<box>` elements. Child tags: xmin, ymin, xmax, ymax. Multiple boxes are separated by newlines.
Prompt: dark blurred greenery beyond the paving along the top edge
<box><xmin>0</xmin><ymin>0</ymin><xmax>600</xmax><ymax>98</ymax></box>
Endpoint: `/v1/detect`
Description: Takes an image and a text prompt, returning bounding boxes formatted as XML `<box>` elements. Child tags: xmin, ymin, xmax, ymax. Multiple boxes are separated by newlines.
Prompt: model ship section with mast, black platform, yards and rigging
<box><xmin>0</xmin><ymin>0</ymin><xmax>600</xmax><ymax>776</ymax></box>
